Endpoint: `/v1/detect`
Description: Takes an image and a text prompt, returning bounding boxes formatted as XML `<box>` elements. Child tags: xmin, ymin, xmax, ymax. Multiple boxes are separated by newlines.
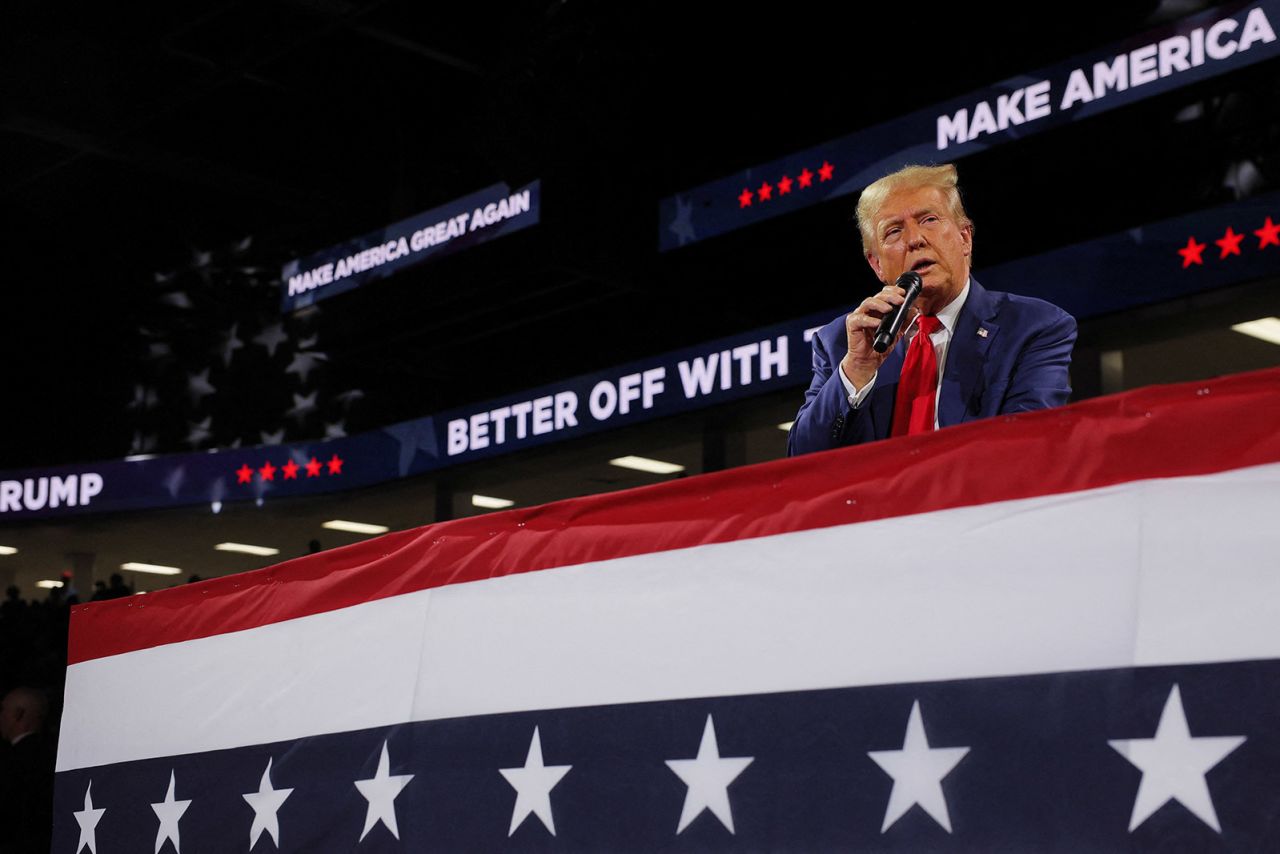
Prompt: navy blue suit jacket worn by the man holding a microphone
<box><xmin>787</xmin><ymin>277</ymin><xmax>1075</xmax><ymax>455</ymax></box>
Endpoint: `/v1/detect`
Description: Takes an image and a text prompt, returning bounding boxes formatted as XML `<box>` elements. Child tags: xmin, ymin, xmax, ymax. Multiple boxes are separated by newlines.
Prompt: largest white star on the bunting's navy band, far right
<box><xmin>1107</xmin><ymin>685</ymin><xmax>1244</xmax><ymax>834</ymax></box>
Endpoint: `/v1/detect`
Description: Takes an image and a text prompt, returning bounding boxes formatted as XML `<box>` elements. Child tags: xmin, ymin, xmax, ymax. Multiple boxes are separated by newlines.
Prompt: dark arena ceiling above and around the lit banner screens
<box><xmin>0</xmin><ymin>0</ymin><xmax>1280</xmax><ymax>469</ymax></box>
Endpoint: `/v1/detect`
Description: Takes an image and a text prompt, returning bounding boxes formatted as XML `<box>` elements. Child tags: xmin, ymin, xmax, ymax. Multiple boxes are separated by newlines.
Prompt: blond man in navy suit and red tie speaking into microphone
<box><xmin>787</xmin><ymin>164</ymin><xmax>1075</xmax><ymax>455</ymax></box>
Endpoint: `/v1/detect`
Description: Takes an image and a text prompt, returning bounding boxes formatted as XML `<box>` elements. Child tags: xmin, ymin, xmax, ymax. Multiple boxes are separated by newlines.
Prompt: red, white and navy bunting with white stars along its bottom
<box><xmin>52</xmin><ymin>371</ymin><xmax>1280</xmax><ymax>854</ymax></box>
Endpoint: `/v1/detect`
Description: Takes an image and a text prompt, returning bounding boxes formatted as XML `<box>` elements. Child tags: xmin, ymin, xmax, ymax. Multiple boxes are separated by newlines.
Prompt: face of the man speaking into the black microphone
<box><xmin>867</xmin><ymin>187</ymin><xmax>973</xmax><ymax>314</ymax></box>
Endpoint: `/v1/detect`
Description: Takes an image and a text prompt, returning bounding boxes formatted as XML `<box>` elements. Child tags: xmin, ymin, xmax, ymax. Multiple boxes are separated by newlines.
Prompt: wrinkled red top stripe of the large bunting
<box><xmin>69</xmin><ymin>369</ymin><xmax>1280</xmax><ymax>663</ymax></box>
